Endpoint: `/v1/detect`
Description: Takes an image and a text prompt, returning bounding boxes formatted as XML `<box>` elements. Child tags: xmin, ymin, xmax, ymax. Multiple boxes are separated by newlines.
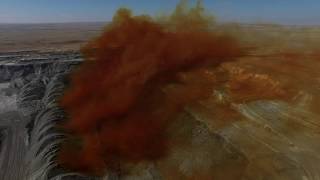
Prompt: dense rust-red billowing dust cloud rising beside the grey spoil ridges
<box><xmin>59</xmin><ymin>1</ymin><xmax>244</xmax><ymax>175</ymax></box>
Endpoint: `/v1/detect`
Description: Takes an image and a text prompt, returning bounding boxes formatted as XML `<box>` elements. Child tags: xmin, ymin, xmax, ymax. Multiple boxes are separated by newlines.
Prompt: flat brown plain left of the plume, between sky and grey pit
<box><xmin>0</xmin><ymin>23</ymin><xmax>105</xmax><ymax>52</ymax></box>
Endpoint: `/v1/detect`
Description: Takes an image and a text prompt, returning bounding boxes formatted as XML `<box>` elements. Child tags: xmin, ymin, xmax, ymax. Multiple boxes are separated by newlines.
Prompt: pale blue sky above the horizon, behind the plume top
<box><xmin>0</xmin><ymin>0</ymin><xmax>320</xmax><ymax>25</ymax></box>
